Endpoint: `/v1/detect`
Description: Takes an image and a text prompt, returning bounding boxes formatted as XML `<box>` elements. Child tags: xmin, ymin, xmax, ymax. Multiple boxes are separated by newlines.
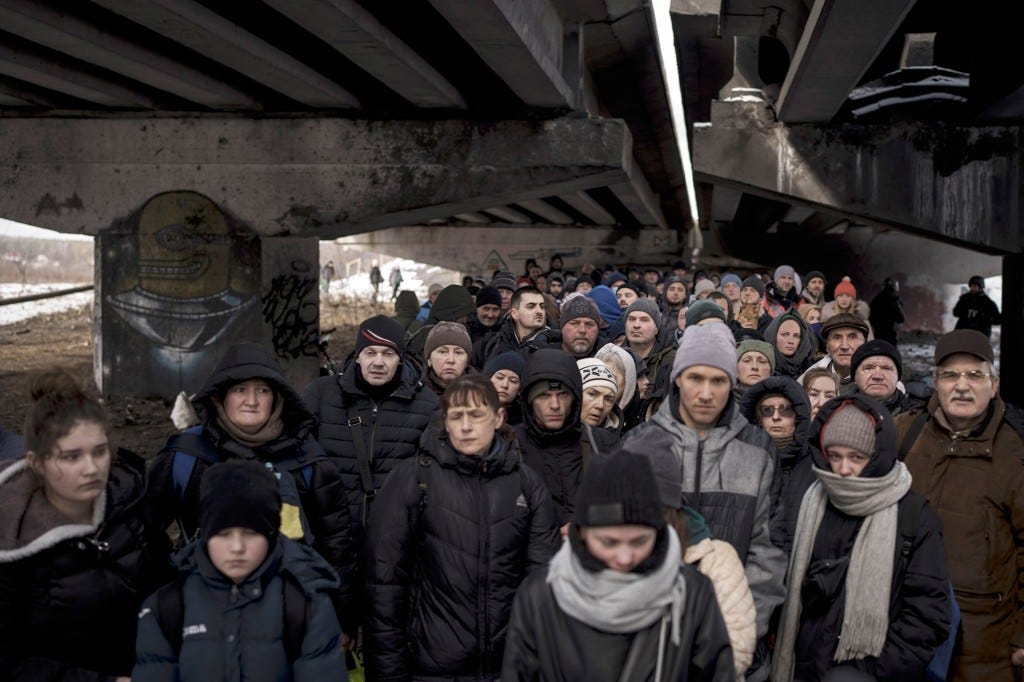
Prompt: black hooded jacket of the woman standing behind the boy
<box><xmin>148</xmin><ymin>343</ymin><xmax>358</xmax><ymax>633</ymax></box>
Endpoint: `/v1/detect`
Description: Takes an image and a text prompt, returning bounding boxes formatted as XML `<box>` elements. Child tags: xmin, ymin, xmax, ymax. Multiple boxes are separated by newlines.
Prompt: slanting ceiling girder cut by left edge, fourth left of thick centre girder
<box><xmin>0</xmin><ymin>45</ymin><xmax>156</xmax><ymax>109</ymax></box>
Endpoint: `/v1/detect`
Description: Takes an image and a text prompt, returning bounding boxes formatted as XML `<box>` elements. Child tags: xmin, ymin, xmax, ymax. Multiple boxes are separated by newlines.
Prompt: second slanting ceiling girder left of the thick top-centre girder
<box><xmin>95</xmin><ymin>0</ymin><xmax>359</xmax><ymax>109</ymax></box>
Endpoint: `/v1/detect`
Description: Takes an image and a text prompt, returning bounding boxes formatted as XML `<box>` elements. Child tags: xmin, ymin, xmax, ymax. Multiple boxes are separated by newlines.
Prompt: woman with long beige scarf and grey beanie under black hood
<box><xmin>772</xmin><ymin>394</ymin><xmax>950</xmax><ymax>682</ymax></box>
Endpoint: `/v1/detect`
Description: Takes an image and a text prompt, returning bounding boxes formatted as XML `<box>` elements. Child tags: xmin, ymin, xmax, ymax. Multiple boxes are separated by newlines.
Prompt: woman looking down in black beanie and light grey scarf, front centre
<box><xmin>502</xmin><ymin>452</ymin><xmax>735</xmax><ymax>682</ymax></box>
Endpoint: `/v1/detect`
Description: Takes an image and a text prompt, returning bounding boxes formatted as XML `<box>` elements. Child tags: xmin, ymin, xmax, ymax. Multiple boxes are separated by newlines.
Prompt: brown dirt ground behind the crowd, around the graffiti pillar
<box><xmin>0</xmin><ymin>296</ymin><xmax>393</xmax><ymax>458</ymax></box>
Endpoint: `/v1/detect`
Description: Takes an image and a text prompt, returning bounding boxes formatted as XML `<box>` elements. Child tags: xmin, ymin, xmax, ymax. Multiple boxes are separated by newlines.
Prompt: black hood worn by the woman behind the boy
<box><xmin>191</xmin><ymin>343</ymin><xmax>313</xmax><ymax>440</ymax></box>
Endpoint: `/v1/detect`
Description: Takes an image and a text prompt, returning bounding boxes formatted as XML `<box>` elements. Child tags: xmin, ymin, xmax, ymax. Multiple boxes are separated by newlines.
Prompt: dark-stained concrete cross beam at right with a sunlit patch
<box><xmin>693</xmin><ymin>102</ymin><xmax>1024</xmax><ymax>254</ymax></box>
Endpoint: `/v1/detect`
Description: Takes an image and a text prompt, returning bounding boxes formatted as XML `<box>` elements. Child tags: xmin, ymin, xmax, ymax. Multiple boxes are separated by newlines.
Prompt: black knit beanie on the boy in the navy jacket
<box><xmin>199</xmin><ymin>460</ymin><xmax>281</xmax><ymax>541</ymax></box>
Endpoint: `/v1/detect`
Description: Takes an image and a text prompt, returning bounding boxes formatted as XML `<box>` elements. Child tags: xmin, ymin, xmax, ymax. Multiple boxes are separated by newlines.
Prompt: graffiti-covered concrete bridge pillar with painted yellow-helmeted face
<box><xmin>93</xmin><ymin>191</ymin><xmax>319</xmax><ymax>397</ymax></box>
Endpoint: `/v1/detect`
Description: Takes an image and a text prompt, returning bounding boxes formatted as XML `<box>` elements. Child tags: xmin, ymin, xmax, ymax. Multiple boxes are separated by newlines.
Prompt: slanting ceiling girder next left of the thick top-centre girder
<box><xmin>263</xmin><ymin>0</ymin><xmax>466</xmax><ymax>109</ymax></box>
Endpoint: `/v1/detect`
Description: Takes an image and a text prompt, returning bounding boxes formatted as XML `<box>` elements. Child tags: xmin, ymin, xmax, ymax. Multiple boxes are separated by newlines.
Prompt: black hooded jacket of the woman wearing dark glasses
<box><xmin>739</xmin><ymin>377</ymin><xmax>814</xmax><ymax>554</ymax></box>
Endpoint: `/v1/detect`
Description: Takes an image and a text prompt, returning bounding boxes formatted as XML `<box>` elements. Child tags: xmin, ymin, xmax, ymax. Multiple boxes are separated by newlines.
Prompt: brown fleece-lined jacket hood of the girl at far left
<box><xmin>0</xmin><ymin>450</ymin><xmax>145</xmax><ymax>563</ymax></box>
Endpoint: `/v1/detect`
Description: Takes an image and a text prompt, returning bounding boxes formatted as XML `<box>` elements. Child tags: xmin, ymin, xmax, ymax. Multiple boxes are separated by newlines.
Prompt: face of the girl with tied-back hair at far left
<box><xmin>29</xmin><ymin>422</ymin><xmax>111</xmax><ymax>512</ymax></box>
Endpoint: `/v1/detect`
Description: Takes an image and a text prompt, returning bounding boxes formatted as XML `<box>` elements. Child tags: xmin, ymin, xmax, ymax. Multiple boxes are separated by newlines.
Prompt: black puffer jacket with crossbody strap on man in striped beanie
<box><xmin>302</xmin><ymin>352</ymin><xmax>440</xmax><ymax>538</ymax></box>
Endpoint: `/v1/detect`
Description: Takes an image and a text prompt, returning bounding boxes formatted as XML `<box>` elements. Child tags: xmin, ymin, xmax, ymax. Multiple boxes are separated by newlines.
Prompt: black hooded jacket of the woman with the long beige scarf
<box><xmin>790</xmin><ymin>395</ymin><xmax>950</xmax><ymax>682</ymax></box>
